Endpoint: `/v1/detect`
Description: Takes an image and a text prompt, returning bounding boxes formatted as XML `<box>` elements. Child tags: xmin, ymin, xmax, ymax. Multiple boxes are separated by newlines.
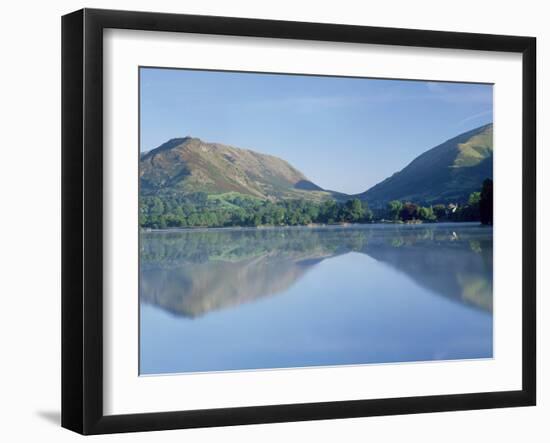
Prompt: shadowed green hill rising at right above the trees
<box><xmin>357</xmin><ymin>123</ymin><xmax>493</xmax><ymax>207</ymax></box>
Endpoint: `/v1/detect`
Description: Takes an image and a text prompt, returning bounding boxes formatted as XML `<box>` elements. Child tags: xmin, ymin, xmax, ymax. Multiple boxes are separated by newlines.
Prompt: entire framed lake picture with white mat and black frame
<box><xmin>62</xmin><ymin>9</ymin><xmax>536</xmax><ymax>434</ymax></box>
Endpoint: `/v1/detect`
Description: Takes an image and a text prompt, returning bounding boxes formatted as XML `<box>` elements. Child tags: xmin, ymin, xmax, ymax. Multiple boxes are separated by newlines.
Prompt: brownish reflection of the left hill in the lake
<box><xmin>140</xmin><ymin>229</ymin><xmax>364</xmax><ymax>317</ymax></box>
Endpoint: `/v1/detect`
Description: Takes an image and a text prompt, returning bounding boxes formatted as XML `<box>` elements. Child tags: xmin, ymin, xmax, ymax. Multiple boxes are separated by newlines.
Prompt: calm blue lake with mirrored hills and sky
<box><xmin>140</xmin><ymin>223</ymin><xmax>493</xmax><ymax>375</ymax></box>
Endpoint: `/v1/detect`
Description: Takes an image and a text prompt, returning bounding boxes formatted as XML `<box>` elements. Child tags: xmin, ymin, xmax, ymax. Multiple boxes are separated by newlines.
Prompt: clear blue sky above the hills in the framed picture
<box><xmin>140</xmin><ymin>68</ymin><xmax>493</xmax><ymax>194</ymax></box>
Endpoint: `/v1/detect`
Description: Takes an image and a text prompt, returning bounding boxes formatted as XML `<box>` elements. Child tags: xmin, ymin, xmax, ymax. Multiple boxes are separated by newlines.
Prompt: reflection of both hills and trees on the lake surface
<box><xmin>140</xmin><ymin>224</ymin><xmax>492</xmax><ymax>318</ymax></box>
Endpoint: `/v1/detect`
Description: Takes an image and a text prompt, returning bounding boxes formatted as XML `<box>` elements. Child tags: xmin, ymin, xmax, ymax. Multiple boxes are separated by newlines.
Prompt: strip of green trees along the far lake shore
<box><xmin>139</xmin><ymin>179</ymin><xmax>493</xmax><ymax>229</ymax></box>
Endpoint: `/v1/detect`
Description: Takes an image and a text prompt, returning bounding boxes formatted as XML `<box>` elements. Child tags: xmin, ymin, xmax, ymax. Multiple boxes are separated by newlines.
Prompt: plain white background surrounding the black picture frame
<box><xmin>0</xmin><ymin>0</ymin><xmax>550</xmax><ymax>443</ymax></box>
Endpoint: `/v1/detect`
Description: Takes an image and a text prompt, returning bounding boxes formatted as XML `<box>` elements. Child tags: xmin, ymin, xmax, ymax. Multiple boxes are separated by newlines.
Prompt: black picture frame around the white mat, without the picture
<box><xmin>62</xmin><ymin>9</ymin><xmax>536</xmax><ymax>434</ymax></box>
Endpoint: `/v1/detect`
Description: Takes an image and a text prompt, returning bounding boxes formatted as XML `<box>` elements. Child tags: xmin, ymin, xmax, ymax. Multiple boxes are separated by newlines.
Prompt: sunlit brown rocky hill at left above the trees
<box><xmin>140</xmin><ymin>137</ymin><xmax>336</xmax><ymax>201</ymax></box>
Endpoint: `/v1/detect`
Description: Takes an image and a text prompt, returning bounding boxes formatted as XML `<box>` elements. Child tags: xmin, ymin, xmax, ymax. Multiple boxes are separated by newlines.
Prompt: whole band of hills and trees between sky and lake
<box><xmin>139</xmin><ymin>124</ymin><xmax>493</xmax><ymax>229</ymax></box>
